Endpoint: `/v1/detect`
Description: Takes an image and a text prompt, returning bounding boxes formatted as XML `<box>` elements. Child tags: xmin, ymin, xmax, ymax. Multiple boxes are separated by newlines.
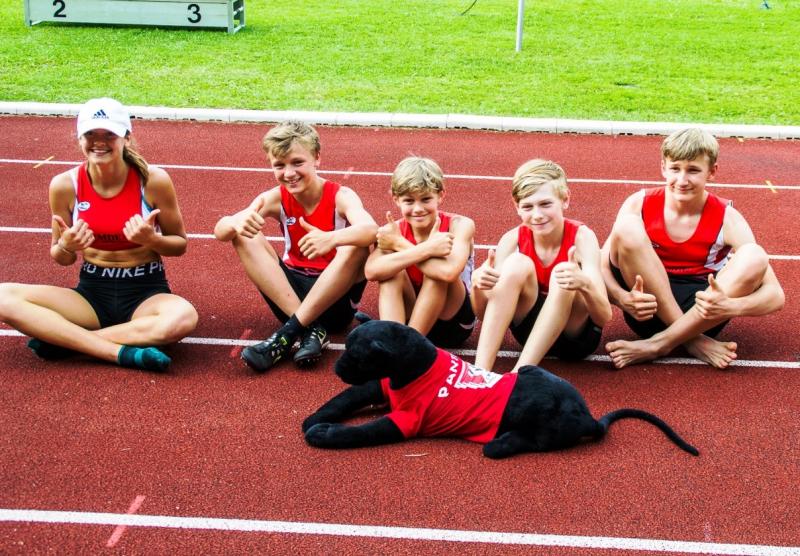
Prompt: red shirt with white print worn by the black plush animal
<box><xmin>381</xmin><ymin>349</ymin><xmax>517</xmax><ymax>443</ymax></box>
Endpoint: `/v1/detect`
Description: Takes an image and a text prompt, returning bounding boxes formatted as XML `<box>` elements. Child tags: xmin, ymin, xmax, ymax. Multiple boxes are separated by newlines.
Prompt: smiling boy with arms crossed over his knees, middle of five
<box><xmin>365</xmin><ymin>157</ymin><xmax>475</xmax><ymax>347</ymax></box>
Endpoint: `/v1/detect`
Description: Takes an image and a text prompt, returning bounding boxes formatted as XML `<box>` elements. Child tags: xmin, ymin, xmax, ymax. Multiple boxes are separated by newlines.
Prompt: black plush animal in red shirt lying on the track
<box><xmin>303</xmin><ymin>321</ymin><xmax>698</xmax><ymax>458</ymax></box>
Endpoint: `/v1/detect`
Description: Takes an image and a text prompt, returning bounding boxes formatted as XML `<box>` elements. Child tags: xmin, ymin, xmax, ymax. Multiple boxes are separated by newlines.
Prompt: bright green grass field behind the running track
<box><xmin>0</xmin><ymin>0</ymin><xmax>800</xmax><ymax>125</ymax></box>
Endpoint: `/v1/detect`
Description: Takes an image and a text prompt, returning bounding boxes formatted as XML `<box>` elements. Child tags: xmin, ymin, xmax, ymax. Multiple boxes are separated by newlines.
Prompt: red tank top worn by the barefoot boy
<box><xmin>642</xmin><ymin>187</ymin><xmax>731</xmax><ymax>276</ymax></box>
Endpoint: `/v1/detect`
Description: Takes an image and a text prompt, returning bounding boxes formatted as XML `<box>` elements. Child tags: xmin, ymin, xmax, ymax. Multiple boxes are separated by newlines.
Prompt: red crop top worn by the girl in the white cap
<box><xmin>70</xmin><ymin>162</ymin><xmax>153</xmax><ymax>251</ymax></box>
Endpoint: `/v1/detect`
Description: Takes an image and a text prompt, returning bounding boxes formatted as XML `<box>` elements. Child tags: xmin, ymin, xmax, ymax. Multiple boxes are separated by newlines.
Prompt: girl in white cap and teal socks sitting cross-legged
<box><xmin>0</xmin><ymin>98</ymin><xmax>197</xmax><ymax>371</ymax></box>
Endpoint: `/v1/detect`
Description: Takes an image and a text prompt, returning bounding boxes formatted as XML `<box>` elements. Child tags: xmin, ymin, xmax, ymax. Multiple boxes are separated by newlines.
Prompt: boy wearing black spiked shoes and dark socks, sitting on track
<box><xmin>214</xmin><ymin>122</ymin><xmax>378</xmax><ymax>372</ymax></box>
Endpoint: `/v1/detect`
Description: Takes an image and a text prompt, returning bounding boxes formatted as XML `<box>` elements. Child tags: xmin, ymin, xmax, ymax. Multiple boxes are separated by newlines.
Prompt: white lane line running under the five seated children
<box><xmin>0</xmin><ymin>329</ymin><xmax>800</xmax><ymax>369</ymax></box>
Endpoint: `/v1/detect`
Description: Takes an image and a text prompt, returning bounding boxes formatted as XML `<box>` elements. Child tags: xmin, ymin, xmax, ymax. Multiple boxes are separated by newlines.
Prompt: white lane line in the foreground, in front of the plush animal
<box><xmin>0</xmin><ymin>509</ymin><xmax>800</xmax><ymax>556</ymax></box>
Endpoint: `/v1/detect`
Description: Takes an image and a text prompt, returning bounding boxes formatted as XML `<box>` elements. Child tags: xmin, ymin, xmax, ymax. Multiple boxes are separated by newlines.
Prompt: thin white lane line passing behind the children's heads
<box><xmin>0</xmin><ymin>158</ymin><xmax>800</xmax><ymax>191</ymax></box>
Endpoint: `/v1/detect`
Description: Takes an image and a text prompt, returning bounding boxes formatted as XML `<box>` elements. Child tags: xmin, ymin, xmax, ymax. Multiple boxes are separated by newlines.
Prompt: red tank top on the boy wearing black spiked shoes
<box><xmin>280</xmin><ymin>181</ymin><xmax>349</xmax><ymax>274</ymax></box>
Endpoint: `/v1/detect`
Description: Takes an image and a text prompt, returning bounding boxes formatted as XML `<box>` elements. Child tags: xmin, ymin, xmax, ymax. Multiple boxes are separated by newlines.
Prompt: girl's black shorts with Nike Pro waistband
<box><xmin>72</xmin><ymin>261</ymin><xmax>172</xmax><ymax>328</ymax></box>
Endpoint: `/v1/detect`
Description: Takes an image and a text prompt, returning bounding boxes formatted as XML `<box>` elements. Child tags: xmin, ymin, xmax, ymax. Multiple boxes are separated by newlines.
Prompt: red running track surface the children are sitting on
<box><xmin>0</xmin><ymin>117</ymin><xmax>800</xmax><ymax>554</ymax></box>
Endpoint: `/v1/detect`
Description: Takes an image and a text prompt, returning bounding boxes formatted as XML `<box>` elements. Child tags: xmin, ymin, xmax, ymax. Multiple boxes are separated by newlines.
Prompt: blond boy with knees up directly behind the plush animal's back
<box><xmin>472</xmin><ymin>159</ymin><xmax>611</xmax><ymax>371</ymax></box>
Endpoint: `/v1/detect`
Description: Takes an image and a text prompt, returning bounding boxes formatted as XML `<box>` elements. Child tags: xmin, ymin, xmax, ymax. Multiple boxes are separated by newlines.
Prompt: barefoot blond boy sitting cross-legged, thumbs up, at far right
<box><xmin>602</xmin><ymin>128</ymin><xmax>784</xmax><ymax>369</ymax></box>
